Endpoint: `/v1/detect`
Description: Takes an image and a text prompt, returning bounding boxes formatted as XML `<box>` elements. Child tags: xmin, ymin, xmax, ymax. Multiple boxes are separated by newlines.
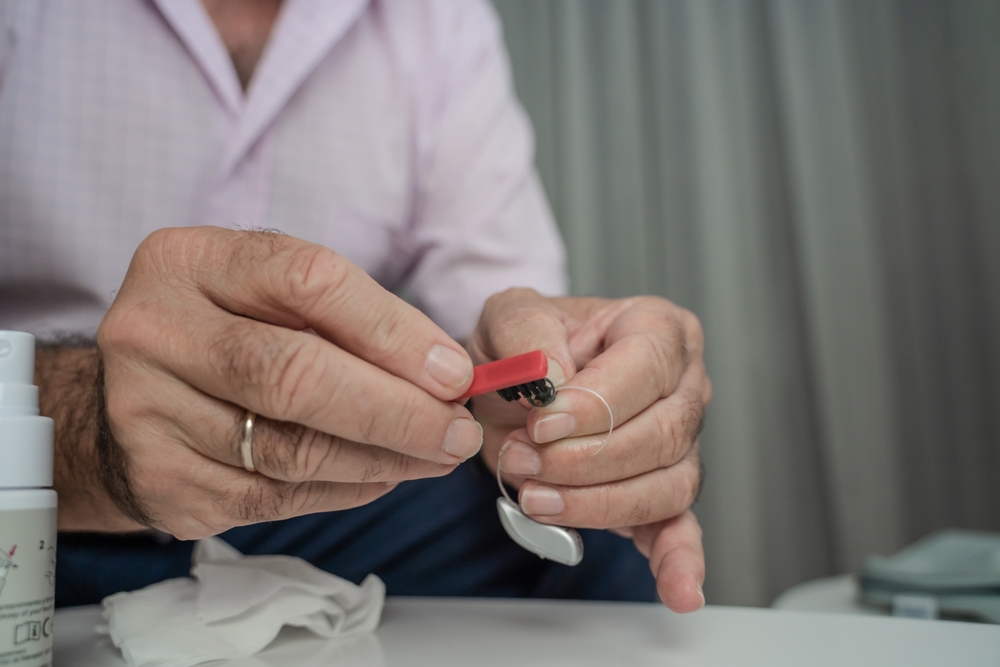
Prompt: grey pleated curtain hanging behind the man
<box><xmin>495</xmin><ymin>0</ymin><xmax>1000</xmax><ymax>604</ymax></box>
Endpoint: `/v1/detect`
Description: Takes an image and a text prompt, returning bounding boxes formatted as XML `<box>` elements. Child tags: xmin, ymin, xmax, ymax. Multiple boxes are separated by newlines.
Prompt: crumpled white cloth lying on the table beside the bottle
<box><xmin>104</xmin><ymin>537</ymin><xmax>385</xmax><ymax>667</ymax></box>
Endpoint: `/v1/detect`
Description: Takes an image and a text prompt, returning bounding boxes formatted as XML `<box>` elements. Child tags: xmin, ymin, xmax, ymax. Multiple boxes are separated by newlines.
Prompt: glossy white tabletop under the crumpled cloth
<box><xmin>54</xmin><ymin>598</ymin><xmax>1000</xmax><ymax>667</ymax></box>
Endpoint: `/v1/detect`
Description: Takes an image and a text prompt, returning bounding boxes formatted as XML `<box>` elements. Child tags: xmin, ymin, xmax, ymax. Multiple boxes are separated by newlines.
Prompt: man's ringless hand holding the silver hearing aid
<box><xmin>469</xmin><ymin>289</ymin><xmax>712</xmax><ymax>612</ymax></box>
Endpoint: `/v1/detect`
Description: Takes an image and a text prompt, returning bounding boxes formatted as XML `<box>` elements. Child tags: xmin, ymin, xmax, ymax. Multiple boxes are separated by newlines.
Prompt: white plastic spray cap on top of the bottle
<box><xmin>0</xmin><ymin>331</ymin><xmax>55</xmax><ymax>489</ymax></box>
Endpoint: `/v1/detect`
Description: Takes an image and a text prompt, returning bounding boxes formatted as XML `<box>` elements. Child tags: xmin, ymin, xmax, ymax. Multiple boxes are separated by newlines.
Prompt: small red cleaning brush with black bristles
<box><xmin>457</xmin><ymin>350</ymin><xmax>556</xmax><ymax>408</ymax></box>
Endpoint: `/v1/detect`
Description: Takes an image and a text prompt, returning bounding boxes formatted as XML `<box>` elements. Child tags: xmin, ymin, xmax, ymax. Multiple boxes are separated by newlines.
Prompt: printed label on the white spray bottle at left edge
<box><xmin>0</xmin><ymin>508</ymin><xmax>56</xmax><ymax>667</ymax></box>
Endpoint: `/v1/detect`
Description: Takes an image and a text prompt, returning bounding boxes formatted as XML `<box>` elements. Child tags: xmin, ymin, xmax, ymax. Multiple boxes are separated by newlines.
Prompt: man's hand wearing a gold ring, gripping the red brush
<box><xmin>52</xmin><ymin>227</ymin><xmax>482</xmax><ymax>539</ymax></box>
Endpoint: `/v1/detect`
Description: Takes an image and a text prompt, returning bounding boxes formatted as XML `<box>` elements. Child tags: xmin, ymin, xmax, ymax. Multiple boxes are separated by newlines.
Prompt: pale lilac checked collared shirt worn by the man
<box><xmin>0</xmin><ymin>0</ymin><xmax>566</xmax><ymax>338</ymax></box>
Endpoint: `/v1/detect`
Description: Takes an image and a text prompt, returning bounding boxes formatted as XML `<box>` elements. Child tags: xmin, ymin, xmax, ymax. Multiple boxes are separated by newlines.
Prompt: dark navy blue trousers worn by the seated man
<box><xmin>56</xmin><ymin>457</ymin><xmax>656</xmax><ymax>607</ymax></box>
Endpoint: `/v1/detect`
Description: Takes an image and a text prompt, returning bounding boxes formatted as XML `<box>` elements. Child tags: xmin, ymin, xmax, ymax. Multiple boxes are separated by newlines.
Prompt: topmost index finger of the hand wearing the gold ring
<box><xmin>176</xmin><ymin>228</ymin><xmax>472</xmax><ymax>400</ymax></box>
